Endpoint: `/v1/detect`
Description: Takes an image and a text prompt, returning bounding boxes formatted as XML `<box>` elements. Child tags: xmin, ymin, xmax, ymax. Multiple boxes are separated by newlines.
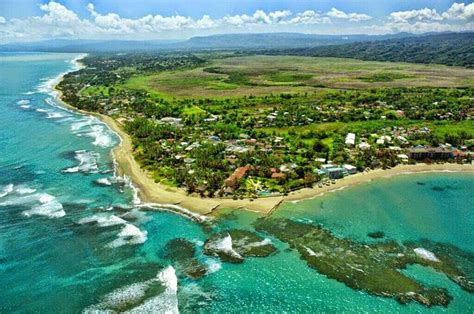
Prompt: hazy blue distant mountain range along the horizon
<box><xmin>0</xmin><ymin>33</ymin><xmax>413</xmax><ymax>52</ymax></box>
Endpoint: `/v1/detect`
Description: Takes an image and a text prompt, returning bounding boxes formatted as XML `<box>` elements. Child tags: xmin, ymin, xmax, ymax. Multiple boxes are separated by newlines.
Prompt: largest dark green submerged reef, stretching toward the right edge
<box><xmin>255</xmin><ymin>219</ymin><xmax>472</xmax><ymax>306</ymax></box>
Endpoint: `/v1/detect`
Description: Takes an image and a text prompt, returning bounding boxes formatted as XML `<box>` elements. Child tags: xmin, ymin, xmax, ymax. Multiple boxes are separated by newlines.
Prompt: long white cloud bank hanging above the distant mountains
<box><xmin>0</xmin><ymin>1</ymin><xmax>474</xmax><ymax>42</ymax></box>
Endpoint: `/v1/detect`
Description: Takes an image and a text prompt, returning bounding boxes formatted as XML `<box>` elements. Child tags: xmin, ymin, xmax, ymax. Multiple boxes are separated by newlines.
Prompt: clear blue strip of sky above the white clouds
<box><xmin>0</xmin><ymin>0</ymin><xmax>464</xmax><ymax>18</ymax></box>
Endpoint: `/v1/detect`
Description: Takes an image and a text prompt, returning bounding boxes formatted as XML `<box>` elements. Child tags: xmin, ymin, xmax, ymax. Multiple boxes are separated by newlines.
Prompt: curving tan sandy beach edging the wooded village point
<box><xmin>54</xmin><ymin>58</ymin><xmax>474</xmax><ymax>216</ymax></box>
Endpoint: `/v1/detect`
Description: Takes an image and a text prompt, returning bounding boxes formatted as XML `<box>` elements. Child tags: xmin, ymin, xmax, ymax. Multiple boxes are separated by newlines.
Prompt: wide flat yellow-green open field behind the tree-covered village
<box><xmin>121</xmin><ymin>56</ymin><xmax>474</xmax><ymax>97</ymax></box>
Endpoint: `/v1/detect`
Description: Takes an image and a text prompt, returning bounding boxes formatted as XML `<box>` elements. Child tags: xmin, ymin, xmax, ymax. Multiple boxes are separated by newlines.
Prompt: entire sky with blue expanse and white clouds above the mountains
<box><xmin>0</xmin><ymin>0</ymin><xmax>474</xmax><ymax>43</ymax></box>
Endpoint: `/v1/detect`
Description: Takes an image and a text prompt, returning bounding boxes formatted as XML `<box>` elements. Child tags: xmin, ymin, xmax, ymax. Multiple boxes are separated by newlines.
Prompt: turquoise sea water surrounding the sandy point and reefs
<box><xmin>0</xmin><ymin>54</ymin><xmax>474</xmax><ymax>313</ymax></box>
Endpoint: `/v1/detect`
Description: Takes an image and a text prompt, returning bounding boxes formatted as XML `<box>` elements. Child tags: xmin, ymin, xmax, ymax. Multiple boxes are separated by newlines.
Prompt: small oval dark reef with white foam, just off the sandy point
<box><xmin>204</xmin><ymin>229</ymin><xmax>277</xmax><ymax>263</ymax></box>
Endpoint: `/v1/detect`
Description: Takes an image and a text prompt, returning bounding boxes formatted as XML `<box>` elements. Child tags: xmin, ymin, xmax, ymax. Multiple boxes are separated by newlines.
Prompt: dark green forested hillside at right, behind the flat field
<box><xmin>258</xmin><ymin>32</ymin><xmax>474</xmax><ymax>68</ymax></box>
